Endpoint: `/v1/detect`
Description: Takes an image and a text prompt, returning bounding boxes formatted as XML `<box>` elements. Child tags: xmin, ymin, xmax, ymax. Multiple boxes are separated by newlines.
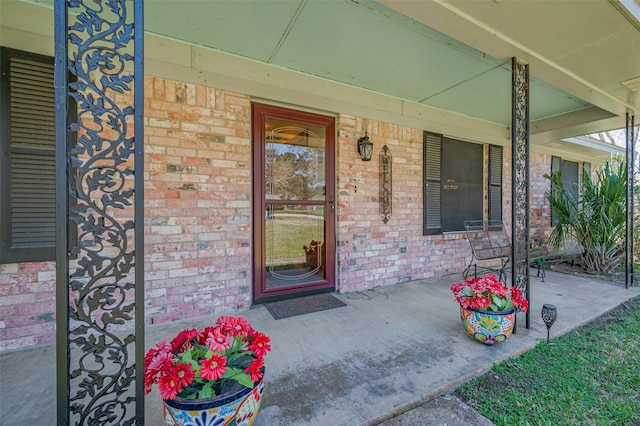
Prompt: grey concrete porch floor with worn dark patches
<box><xmin>0</xmin><ymin>270</ymin><xmax>640</xmax><ymax>426</ymax></box>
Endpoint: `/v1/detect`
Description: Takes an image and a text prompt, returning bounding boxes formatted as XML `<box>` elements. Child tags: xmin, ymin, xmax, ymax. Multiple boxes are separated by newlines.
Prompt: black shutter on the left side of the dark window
<box><xmin>423</xmin><ymin>132</ymin><xmax>443</xmax><ymax>235</ymax></box>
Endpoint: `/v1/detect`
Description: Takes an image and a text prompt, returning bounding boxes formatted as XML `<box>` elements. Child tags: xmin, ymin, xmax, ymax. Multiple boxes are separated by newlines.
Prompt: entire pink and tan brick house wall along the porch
<box><xmin>0</xmin><ymin>76</ymin><xmax>551</xmax><ymax>350</ymax></box>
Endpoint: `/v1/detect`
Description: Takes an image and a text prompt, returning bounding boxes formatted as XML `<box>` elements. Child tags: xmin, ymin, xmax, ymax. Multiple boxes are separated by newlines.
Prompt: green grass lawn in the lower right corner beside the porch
<box><xmin>455</xmin><ymin>297</ymin><xmax>640</xmax><ymax>425</ymax></box>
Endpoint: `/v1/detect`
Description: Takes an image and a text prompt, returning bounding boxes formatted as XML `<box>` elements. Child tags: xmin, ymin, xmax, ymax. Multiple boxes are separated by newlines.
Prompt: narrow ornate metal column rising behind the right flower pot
<box><xmin>511</xmin><ymin>57</ymin><xmax>531</xmax><ymax>328</ymax></box>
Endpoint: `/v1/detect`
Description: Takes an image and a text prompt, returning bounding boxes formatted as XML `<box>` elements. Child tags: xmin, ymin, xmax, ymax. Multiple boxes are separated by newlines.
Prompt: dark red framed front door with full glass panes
<box><xmin>253</xmin><ymin>104</ymin><xmax>335</xmax><ymax>303</ymax></box>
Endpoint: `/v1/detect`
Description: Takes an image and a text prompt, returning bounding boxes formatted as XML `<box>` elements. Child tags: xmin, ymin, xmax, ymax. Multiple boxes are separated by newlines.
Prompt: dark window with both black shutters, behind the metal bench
<box><xmin>423</xmin><ymin>132</ymin><xmax>502</xmax><ymax>235</ymax></box>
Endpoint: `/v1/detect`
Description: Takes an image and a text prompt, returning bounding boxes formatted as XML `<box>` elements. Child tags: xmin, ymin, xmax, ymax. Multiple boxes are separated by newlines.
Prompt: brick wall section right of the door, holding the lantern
<box><xmin>337</xmin><ymin>115</ymin><xmax>471</xmax><ymax>292</ymax></box>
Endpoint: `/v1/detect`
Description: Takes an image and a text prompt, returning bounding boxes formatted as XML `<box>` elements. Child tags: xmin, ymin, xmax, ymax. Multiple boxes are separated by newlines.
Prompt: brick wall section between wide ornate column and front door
<box><xmin>144</xmin><ymin>77</ymin><xmax>251</xmax><ymax>323</ymax></box>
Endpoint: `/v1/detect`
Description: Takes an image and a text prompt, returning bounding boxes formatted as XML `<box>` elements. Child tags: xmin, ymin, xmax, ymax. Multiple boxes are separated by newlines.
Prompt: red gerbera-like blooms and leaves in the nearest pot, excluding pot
<box><xmin>144</xmin><ymin>316</ymin><xmax>271</xmax><ymax>400</ymax></box>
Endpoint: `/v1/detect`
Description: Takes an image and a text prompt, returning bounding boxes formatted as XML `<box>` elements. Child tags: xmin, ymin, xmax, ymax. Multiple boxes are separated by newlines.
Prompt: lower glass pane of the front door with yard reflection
<box><xmin>265</xmin><ymin>204</ymin><xmax>326</xmax><ymax>288</ymax></box>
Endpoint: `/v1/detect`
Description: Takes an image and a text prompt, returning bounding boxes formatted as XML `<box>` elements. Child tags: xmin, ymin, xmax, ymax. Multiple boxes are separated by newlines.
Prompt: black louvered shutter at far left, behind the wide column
<box><xmin>0</xmin><ymin>47</ymin><xmax>55</xmax><ymax>263</ymax></box>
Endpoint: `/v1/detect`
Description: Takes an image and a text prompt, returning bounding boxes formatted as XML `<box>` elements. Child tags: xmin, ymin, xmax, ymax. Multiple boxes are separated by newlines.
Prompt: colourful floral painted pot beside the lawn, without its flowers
<box><xmin>460</xmin><ymin>306</ymin><xmax>516</xmax><ymax>345</ymax></box>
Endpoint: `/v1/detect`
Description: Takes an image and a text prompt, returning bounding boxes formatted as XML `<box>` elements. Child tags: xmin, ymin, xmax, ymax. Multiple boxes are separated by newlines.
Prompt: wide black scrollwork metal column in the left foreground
<box><xmin>55</xmin><ymin>0</ymin><xmax>144</xmax><ymax>425</ymax></box>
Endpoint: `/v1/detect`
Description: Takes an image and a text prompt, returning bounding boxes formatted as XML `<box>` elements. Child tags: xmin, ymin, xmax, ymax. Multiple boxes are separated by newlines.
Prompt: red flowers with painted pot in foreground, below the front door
<box><xmin>144</xmin><ymin>316</ymin><xmax>271</xmax><ymax>425</ymax></box>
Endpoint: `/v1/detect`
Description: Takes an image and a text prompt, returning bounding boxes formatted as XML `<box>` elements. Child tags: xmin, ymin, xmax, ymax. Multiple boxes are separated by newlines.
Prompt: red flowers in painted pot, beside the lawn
<box><xmin>451</xmin><ymin>274</ymin><xmax>529</xmax><ymax>345</ymax></box>
